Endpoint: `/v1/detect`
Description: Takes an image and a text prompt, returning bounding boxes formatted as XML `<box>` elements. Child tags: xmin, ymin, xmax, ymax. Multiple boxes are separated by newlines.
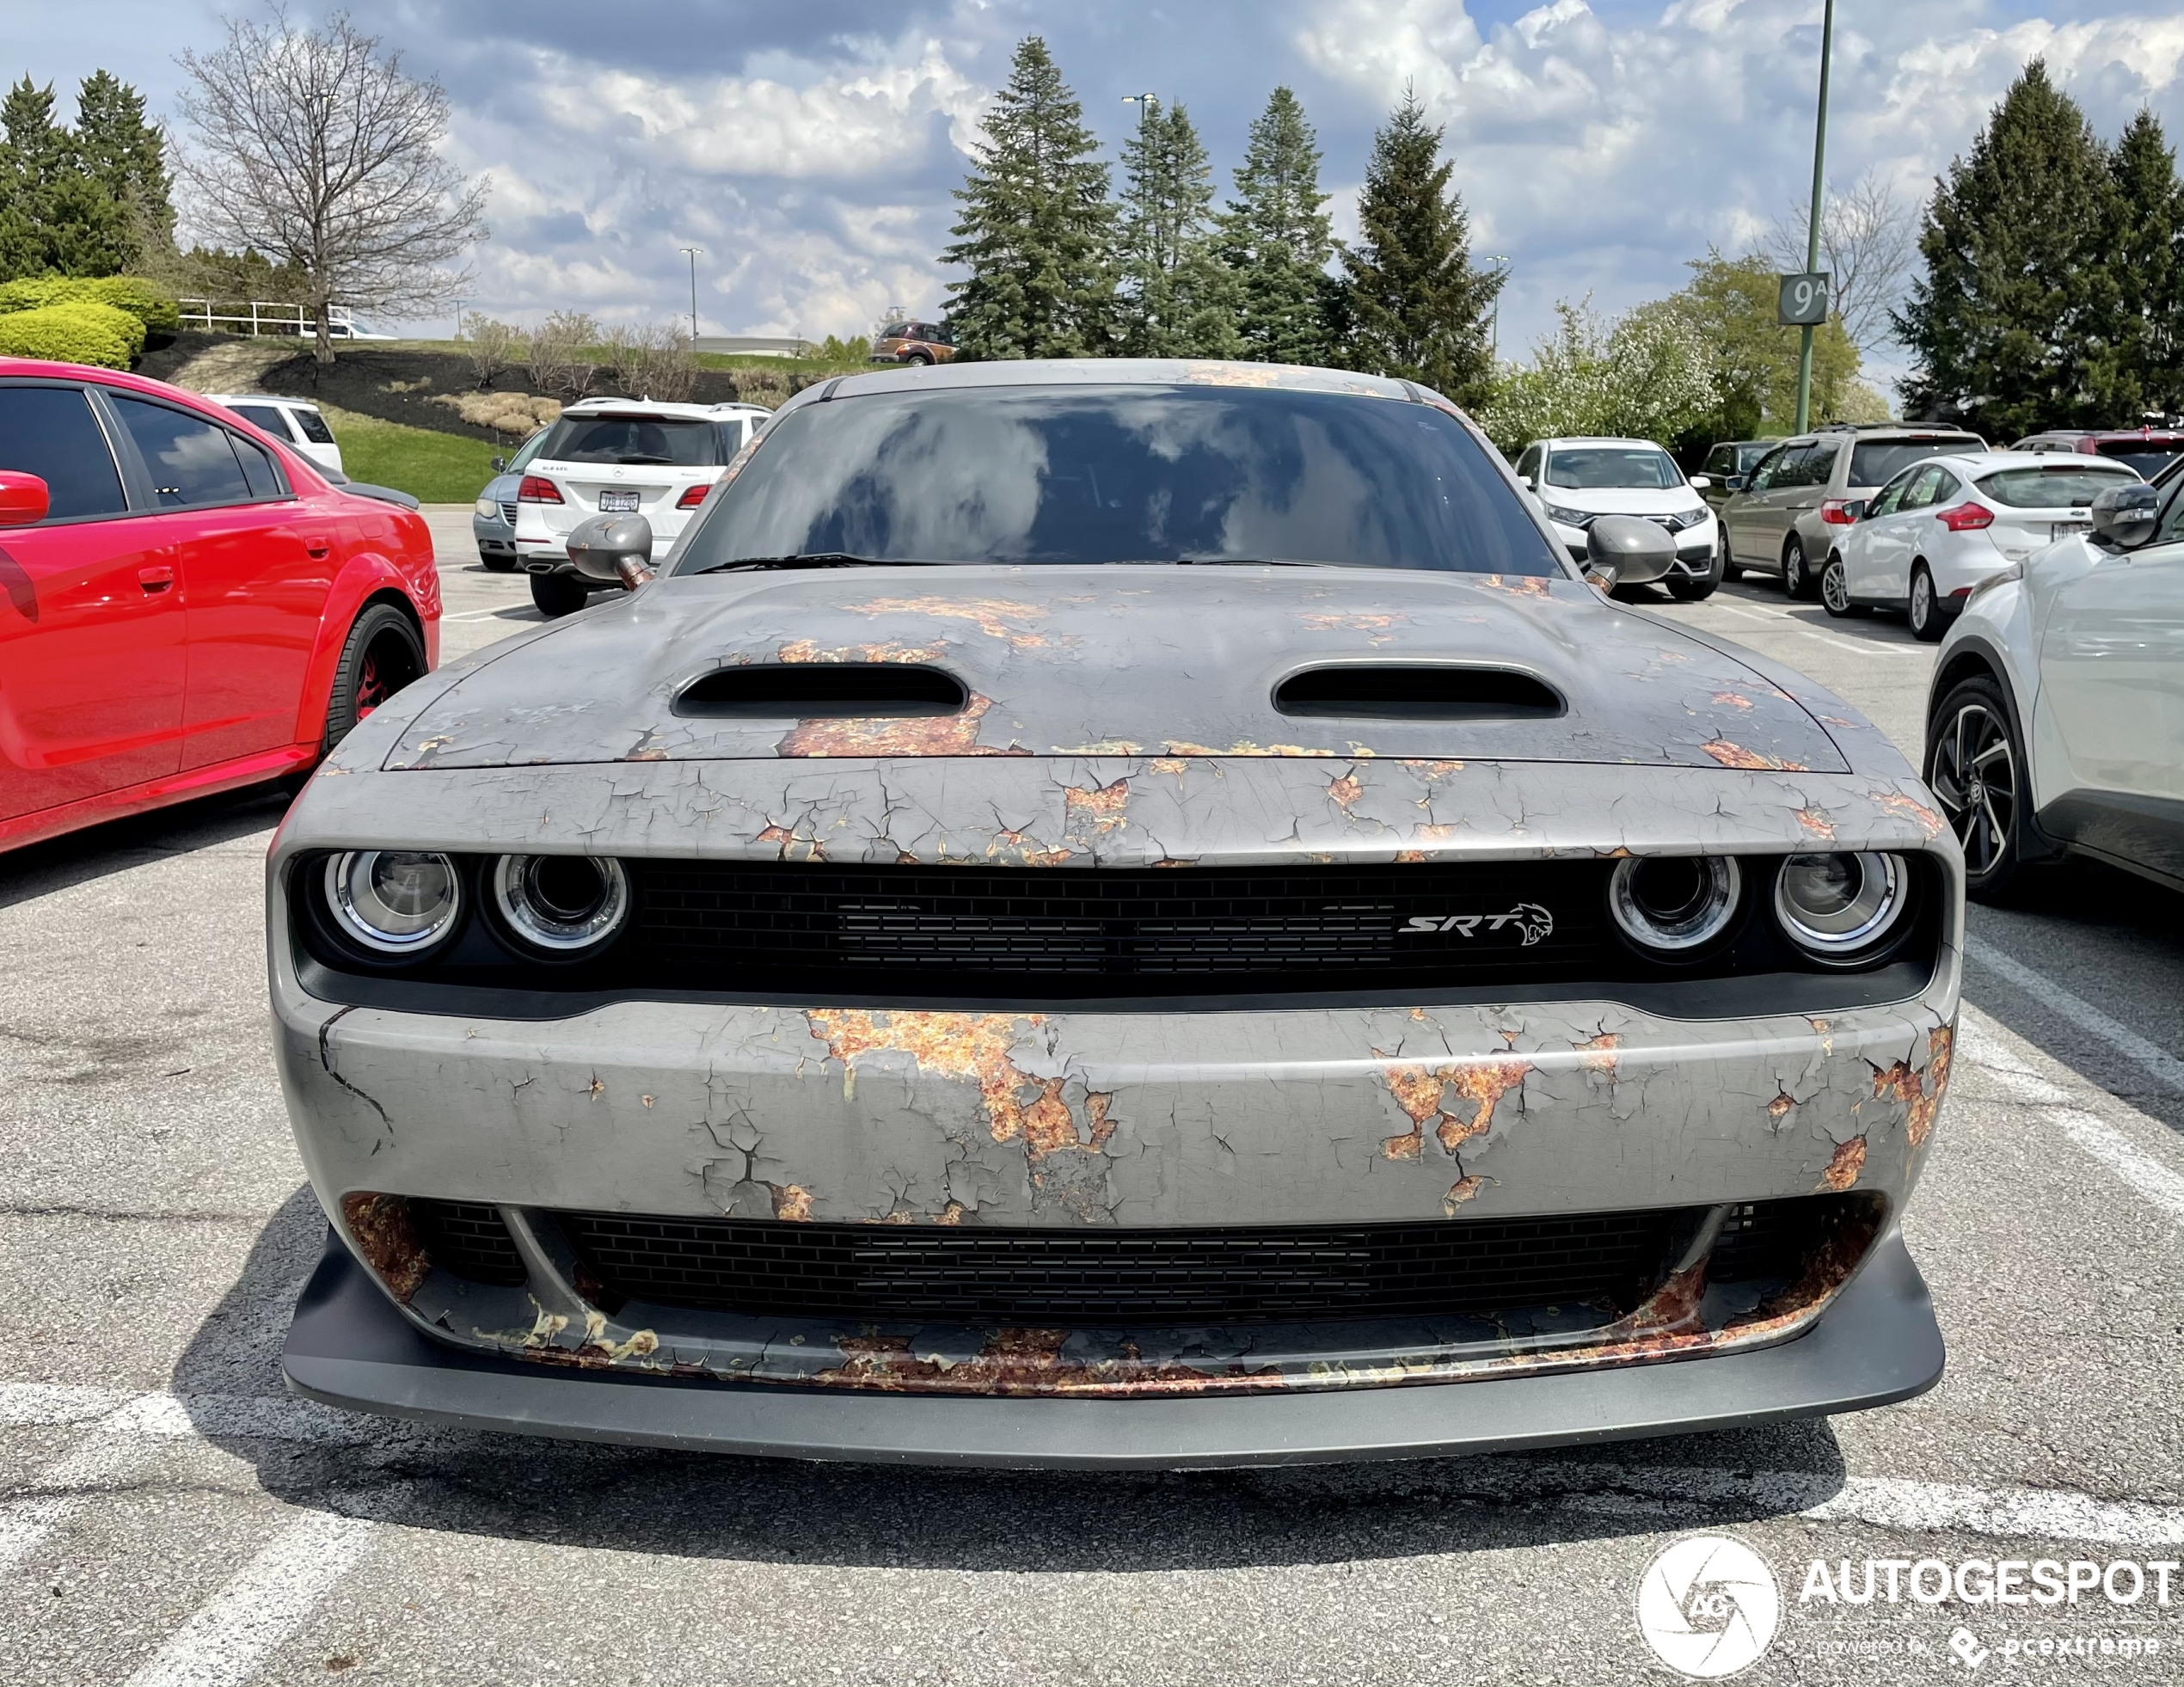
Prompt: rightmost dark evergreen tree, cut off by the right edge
<box><xmin>2090</xmin><ymin>109</ymin><xmax>2184</xmax><ymax>426</ymax></box>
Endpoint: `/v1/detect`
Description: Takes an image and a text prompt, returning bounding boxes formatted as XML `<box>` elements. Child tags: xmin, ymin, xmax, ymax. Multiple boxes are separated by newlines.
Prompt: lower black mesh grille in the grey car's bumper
<box><xmin>561</xmin><ymin>1208</ymin><xmax>1699</xmax><ymax>1327</ymax></box>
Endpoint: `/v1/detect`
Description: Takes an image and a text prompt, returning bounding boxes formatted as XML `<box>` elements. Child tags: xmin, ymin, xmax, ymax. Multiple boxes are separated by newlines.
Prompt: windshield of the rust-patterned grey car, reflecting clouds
<box><xmin>675</xmin><ymin>384</ymin><xmax>1564</xmax><ymax>574</ymax></box>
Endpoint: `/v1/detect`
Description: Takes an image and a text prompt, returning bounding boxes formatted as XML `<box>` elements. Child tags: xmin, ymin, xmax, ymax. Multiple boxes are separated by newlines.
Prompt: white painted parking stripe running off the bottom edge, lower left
<box><xmin>129</xmin><ymin>1512</ymin><xmax>371</xmax><ymax>1687</ymax></box>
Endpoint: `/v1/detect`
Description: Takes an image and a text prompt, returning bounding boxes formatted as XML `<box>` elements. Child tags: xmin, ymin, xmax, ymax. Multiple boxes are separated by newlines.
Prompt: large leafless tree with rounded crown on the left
<box><xmin>177</xmin><ymin>3</ymin><xmax>487</xmax><ymax>363</ymax></box>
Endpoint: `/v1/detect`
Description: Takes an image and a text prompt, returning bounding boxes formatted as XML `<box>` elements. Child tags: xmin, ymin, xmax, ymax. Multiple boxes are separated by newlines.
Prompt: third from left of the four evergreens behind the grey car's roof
<box><xmin>1218</xmin><ymin>88</ymin><xmax>1334</xmax><ymax>363</ymax></box>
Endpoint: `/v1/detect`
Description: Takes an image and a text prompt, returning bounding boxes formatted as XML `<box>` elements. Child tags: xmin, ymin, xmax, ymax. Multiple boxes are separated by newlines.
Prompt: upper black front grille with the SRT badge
<box><xmin>635</xmin><ymin>861</ymin><xmax>1627</xmax><ymax>994</ymax></box>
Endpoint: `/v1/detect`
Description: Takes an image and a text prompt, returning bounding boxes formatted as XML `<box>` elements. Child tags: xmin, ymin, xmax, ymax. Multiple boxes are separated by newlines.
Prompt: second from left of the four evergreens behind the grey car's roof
<box><xmin>1118</xmin><ymin>105</ymin><xmax>1242</xmax><ymax>359</ymax></box>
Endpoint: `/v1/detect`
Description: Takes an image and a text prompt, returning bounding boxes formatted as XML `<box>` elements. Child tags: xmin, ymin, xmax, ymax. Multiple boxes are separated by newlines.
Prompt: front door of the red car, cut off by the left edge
<box><xmin>0</xmin><ymin>380</ymin><xmax>183</xmax><ymax>819</ymax></box>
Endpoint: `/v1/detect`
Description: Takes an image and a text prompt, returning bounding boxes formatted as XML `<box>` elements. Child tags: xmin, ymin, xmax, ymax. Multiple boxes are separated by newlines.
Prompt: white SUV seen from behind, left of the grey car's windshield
<box><xmin>515</xmin><ymin>398</ymin><xmax>771</xmax><ymax>617</ymax></box>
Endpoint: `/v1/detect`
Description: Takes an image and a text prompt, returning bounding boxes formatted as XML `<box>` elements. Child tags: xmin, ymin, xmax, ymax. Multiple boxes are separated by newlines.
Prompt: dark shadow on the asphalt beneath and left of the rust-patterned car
<box><xmin>173</xmin><ymin>1187</ymin><xmax>1845</xmax><ymax>1571</ymax></box>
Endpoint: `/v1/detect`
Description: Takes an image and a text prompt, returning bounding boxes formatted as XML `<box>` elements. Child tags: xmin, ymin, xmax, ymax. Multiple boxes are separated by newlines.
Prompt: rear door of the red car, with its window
<box><xmin>107</xmin><ymin>391</ymin><xmax>328</xmax><ymax>770</ymax></box>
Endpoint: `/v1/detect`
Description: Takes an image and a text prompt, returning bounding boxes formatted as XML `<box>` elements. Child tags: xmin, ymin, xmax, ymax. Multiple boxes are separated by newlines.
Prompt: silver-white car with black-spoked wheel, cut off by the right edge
<box><xmin>1926</xmin><ymin>479</ymin><xmax>2184</xmax><ymax>900</ymax></box>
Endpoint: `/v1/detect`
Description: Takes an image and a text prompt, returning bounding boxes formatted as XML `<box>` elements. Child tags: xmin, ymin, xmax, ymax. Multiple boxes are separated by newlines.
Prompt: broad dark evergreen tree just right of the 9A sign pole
<box><xmin>1893</xmin><ymin>59</ymin><xmax>2116</xmax><ymax>439</ymax></box>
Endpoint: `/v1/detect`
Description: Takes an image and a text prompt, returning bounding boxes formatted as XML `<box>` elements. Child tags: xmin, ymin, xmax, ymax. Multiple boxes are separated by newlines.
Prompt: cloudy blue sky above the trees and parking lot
<box><xmin>12</xmin><ymin>0</ymin><xmax>2184</xmax><ymax>384</ymax></box>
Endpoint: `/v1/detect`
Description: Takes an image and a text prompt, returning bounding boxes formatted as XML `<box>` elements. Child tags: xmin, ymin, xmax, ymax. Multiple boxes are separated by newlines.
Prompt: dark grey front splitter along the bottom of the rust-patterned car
<box><xmin>282</xmin><ymin>1230</ymin><xmax>1944</xmax><ymax>1470</ymax></box>
